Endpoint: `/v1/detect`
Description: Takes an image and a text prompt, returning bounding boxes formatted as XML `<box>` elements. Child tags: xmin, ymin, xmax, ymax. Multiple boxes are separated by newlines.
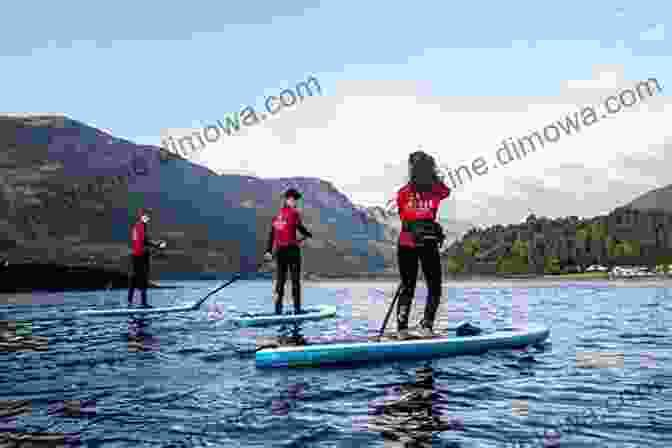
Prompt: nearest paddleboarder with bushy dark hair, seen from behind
<box><xmin>396</xmin><ymin>151</ymin><xmax>450</xmax><ymax>339</ymax></box>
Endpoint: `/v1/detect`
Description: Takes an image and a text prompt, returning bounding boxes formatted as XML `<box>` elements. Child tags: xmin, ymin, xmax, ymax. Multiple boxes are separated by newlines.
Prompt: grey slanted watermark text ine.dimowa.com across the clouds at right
<box><xmin>441</xmin><ymin>78</ymin><xmax>662</xmax><ymax>188</ymax></box>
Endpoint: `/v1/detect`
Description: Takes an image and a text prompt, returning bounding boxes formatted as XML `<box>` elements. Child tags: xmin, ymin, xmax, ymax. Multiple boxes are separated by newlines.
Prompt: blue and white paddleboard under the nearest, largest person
<box><xmin>255</xmin><ymin>324</ymin><xmax>550</xmax><ymax>368</ymax></box>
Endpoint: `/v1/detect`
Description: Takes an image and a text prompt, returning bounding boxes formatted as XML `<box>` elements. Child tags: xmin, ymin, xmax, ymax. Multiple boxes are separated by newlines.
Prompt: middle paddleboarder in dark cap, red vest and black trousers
<box><xmin>264</xmin><ymin>188</ymin><xmax>313</xmax><ymax>314</ymax></box>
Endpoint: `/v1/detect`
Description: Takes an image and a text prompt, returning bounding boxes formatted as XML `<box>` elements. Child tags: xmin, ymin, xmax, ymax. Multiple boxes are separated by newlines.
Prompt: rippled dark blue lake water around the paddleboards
<box><xmin>0</xmin><ymin>280</ymin><xmax>672</xmax><ymax>448</ymax></box>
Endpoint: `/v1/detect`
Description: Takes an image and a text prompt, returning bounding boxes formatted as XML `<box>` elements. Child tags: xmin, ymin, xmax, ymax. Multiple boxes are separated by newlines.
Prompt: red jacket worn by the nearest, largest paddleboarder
<box><xmin>397</xmin><ymin>183</ymin><xmax>450</xmax><ymax>247</ymax></box>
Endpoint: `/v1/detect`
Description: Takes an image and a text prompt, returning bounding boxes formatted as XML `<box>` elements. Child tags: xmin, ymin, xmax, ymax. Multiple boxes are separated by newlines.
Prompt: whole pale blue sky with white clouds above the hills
<box><xmin>0</xmin><ymin>0</ymin><xmax>672</xmax><ymax>225</ymax></box>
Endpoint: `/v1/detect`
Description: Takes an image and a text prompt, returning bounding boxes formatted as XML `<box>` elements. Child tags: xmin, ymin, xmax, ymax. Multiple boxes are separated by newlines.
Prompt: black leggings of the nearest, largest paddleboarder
<box><xmin>397</xmin><ymin>245</ymin><xmax>443</xmax><ymax>330</ymax></box>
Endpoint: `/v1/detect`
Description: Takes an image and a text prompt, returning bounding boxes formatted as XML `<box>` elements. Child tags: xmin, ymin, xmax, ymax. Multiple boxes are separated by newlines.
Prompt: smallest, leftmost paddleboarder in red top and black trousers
<box><xmin>128</xmin><ymin>208</ymin><xmax>166</xmax><ymax>308</ymax></box>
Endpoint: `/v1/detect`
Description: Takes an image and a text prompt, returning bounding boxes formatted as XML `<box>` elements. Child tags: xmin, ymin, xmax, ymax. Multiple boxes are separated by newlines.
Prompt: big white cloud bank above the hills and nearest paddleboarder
<box><xmin>184</xmin><ymin>66</ymin><xmax>672</xmax><ymax>225</ymax></box>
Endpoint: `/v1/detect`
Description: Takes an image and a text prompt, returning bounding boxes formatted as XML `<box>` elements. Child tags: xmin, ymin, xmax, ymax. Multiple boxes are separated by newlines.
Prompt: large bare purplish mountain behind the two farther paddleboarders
<box><xmin>0</xmin><ymin>116</ymin><xmax>395</xmax><ymax>286</ymax></box>
